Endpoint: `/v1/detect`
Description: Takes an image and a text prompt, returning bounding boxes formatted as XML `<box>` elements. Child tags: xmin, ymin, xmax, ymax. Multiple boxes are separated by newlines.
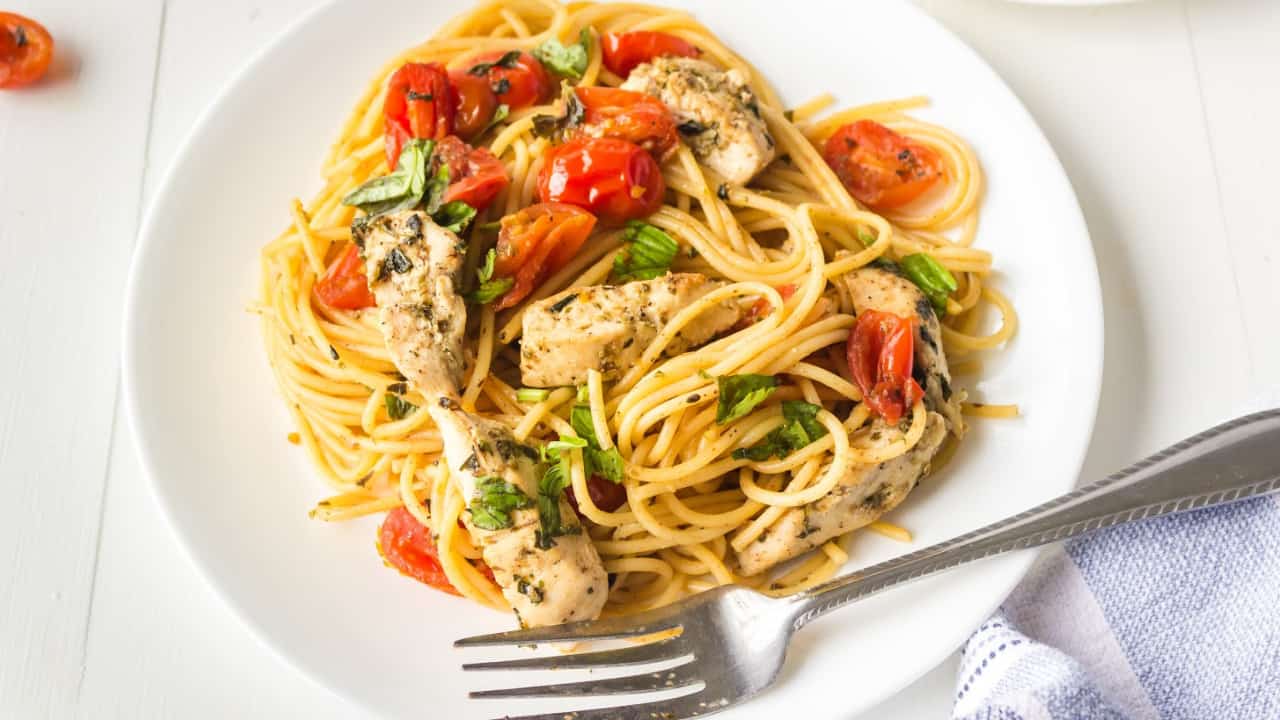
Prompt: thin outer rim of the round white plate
<box><xmin>120</xmin><ymin>0</ymin><xmax>1125</xmax><ymax>716</ymax></box>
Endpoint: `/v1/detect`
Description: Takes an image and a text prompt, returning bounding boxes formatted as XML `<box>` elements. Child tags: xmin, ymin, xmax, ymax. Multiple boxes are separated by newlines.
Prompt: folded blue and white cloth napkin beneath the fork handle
<box><xmin>954</xmin><ymin>394</ymin><xmax>1280</xmax><ymax>720</ymax></box>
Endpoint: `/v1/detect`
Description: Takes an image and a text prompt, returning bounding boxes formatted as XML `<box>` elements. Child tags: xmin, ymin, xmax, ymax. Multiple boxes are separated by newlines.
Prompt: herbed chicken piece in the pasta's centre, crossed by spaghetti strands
<box><xmin>520</xmin><ymin>273</ymin><xmax>741</xmax><ymax>387</ymax></box>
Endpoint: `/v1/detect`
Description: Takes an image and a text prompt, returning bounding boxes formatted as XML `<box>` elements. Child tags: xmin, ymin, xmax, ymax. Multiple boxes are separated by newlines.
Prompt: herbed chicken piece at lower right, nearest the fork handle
<box><xmin>737</xmin><ymin>413</ymin><xmax>947</xmax><ymax>575</ymax></box>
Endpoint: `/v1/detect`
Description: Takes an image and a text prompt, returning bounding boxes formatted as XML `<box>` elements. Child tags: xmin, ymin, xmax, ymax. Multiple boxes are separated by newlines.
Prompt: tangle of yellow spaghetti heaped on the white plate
<box><xmin>260</xmin><ymin>0</ymin><xmax>1016</xmax><ymax>614</ymax></box>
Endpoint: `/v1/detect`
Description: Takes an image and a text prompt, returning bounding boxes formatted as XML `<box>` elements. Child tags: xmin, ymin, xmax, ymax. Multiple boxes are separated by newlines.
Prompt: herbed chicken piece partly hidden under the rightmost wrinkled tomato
<box><xmin>845</xmin><ymin>264</ymin><xmax>965</xmax><ymax>437</ymax></box>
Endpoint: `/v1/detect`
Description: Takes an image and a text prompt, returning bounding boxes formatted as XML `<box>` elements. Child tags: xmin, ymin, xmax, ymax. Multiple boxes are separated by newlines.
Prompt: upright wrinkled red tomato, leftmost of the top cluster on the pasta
<box><xmin>383</xmin><ymin>63</ymin><xmax>454</xmax><ymax>168</ymax></box>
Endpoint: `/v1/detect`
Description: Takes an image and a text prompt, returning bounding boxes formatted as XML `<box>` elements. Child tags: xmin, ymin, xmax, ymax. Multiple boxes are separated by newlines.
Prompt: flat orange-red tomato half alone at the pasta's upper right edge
<box><xmin>822</xmin><ymin>120</ymin><xmax>942</xmax><ymax>210</ymax></box>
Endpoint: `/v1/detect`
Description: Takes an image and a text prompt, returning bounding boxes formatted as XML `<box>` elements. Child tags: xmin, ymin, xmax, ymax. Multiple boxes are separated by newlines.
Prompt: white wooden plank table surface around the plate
<box><xmin>0</xmin><ymin>0</ymin><xmax>1280</xmax><ymax>717</ymax></box>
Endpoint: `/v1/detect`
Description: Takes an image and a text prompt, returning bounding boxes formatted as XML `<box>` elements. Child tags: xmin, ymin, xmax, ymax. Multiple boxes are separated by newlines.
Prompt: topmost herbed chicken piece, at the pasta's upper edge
<box><xmin>622</xmin><ymin>58</ymin><xmax>773</xmax><ymax>184</ymax></box>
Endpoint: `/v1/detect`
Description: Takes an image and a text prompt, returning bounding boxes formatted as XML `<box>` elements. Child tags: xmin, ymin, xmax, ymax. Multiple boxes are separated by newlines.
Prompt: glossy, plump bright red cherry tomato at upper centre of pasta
<box><xmin>538</xmin><ymin>137</ymin><xmax>667</xmax><ymax>224</ymax></box>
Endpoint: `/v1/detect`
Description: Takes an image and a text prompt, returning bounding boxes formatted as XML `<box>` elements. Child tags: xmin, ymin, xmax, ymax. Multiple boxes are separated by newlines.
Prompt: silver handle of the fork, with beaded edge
<box><xmin>791</xmin><ymin>410</ymin><xmax>1280</xmax><ymax>629</ymax></box>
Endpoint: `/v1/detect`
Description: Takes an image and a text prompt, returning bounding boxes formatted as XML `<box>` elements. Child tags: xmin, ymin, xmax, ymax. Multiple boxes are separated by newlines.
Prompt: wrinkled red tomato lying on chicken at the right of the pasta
<box><xmin>846</xmin><ymin>310</ymin><xmax>924</xmax><ymax>425</ymax></box>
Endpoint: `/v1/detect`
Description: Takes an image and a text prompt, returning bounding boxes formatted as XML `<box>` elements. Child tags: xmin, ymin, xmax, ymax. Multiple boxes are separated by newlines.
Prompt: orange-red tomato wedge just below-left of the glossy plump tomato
<box><xmin>493</xmin><ymin>202</ymin><xmax>595</xmax><ymax>310</ymax></box>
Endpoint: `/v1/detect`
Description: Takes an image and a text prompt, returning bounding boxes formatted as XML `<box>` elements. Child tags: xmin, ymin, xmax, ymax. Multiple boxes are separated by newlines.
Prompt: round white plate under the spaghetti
<box><xmin>124</xmin><ymin>0</ymin><xmax>1102</xmax><ymax>720</ymax></box>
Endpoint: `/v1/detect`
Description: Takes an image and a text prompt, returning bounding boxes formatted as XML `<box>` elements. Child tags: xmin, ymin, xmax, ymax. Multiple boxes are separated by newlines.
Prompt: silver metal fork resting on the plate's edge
<box><xmin>453</xmin><ymin>410</ymin><xmax>1280</xmax><ymax>720</ymax></box>
